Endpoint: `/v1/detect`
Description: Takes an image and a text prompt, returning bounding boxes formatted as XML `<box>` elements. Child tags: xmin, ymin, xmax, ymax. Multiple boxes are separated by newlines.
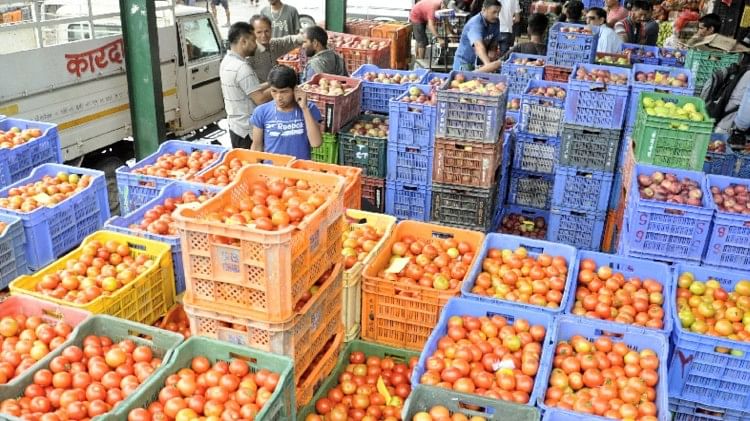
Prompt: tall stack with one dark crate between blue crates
<box><xmin>548</xmin><ymin>64</ymin><xmax>630</xmax><ymax>250</ymax></box>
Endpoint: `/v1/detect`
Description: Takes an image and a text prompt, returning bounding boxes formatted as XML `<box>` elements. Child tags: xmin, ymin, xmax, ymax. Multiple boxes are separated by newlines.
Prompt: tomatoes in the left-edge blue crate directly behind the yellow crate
<box><xmin>0</xmin><ymin>171</ymin><xmax>92</xmax><ymax>212</ymax></box>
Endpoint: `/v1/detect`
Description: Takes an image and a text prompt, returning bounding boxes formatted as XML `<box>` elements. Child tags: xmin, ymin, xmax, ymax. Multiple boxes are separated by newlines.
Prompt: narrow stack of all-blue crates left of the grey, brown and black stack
<box><xmin>385</xmin><ymin>84</ymin><xmax>437</xmax><ymax>221</ymax></box>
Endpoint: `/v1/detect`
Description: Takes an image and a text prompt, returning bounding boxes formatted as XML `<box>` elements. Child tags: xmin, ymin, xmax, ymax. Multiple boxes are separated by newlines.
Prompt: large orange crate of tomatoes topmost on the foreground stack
<box><xmin>174</xmin><ymin>165</ymin><xmax>344</xmax><ymax>322</ymax></box>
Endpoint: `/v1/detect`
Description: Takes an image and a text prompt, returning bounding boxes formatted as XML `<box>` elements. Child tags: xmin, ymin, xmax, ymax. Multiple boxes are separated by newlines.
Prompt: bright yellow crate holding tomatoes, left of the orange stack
<box><xmin>10</xmin><ymin>231</ymin><xmax>175</xmax><ymax>325</ymax></box>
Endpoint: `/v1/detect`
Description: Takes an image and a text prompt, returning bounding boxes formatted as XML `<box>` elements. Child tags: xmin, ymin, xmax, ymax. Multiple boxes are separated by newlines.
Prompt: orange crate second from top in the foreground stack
<box><xmin>184</xmin><ymin>259</ymin><xmax>344</xmax><ymax>381</ymax></box>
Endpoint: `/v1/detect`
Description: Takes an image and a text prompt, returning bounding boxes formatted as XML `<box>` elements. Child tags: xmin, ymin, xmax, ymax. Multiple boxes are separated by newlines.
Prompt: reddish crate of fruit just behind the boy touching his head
<box><xmin>301</xmin><ymin>71</ymin><xmax>362</xmax><ymax>133</ymax></box>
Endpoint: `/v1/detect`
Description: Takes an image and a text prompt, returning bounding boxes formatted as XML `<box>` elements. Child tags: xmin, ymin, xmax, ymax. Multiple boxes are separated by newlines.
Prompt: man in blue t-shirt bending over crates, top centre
<box><xmin>453</xmin><ymin>0</ymin><xmax>501</xmax><ymax>70</ymax></box>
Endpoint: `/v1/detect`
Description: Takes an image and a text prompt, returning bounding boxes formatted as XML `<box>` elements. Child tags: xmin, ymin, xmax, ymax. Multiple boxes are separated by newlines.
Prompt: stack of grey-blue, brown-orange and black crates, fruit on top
<box><xmin>428</xmin><ymin>72</ymin><xmax>508</xmax><ymax>232</ymax></box>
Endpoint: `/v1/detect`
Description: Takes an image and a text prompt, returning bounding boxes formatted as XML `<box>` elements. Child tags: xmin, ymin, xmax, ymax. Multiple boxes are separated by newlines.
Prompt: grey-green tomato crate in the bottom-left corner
<box><xmin>0</xmin><ymin>314</ymin><xmax>183</xmax><ymax>421</ymax></box>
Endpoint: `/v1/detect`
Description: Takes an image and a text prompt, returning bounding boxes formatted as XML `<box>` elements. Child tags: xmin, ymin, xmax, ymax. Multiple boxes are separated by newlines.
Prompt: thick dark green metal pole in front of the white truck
<box><xmin>120</xmin><ymin>0</ymin><xmax>166</xmax><ymax>159</ymax></box>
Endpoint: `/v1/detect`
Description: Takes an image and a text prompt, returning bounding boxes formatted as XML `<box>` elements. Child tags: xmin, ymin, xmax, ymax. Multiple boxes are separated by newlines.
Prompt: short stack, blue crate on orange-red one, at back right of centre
<box><xmin>544</xmin><ymin>22</ymin><xmax>599</xmax><ymax>83</ymax></box>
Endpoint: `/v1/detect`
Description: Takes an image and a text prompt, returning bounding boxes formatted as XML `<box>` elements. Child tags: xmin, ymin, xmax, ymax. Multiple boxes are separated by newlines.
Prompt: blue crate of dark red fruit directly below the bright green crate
<box><xmin>623</xmin><ymin>164</ymin><xmax>713</xmax><ymax>262</ymax></box>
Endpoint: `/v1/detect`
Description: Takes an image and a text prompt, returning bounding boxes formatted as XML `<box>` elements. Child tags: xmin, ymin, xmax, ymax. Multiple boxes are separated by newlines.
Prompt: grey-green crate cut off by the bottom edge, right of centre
<box><xmin>401</xmin><ymin>384</ymin><xmax>540</xmax><ymax>421</ymax></box>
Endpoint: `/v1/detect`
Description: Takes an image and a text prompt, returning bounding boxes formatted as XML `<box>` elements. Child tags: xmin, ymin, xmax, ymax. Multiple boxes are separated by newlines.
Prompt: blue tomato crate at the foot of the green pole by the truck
<box><xmin>115</xmin><ymin>140</ymin><xmax>227</xmax><ymax>215</ymax></box>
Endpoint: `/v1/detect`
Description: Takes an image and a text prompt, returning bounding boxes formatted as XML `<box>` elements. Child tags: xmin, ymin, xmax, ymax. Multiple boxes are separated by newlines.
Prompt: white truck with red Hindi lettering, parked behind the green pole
<box><xmin>0</xmin><ymin>0</ymin><xmax>225</xmax><ymax>209</ymax></box>
